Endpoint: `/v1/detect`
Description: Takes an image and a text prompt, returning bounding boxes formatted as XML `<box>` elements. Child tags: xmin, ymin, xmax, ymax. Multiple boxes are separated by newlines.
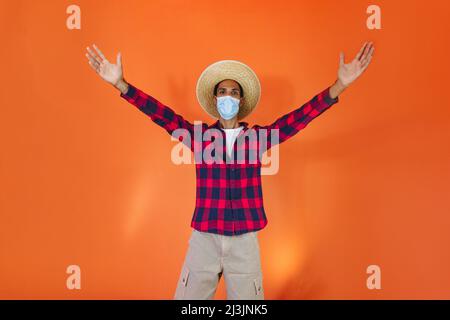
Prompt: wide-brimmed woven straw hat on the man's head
<box><xmin>196</xmin><ymin>60</ymin><xmax>261</xmax><ymax>120</ymax></box>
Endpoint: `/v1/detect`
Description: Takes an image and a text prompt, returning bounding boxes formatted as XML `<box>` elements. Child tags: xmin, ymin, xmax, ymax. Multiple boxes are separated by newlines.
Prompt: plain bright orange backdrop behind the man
<box><xmin>0</xmin><ymin>0</ymin><xmax>450</xmax><ymax>299</ymax></box>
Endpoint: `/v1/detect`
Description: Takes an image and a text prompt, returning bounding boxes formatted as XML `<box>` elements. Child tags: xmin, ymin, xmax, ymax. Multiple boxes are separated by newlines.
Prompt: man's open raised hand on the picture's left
<box><xmin>86</xmin><ymin>44</ymin><xmax>123</xmax><ymax>86</ymax></box>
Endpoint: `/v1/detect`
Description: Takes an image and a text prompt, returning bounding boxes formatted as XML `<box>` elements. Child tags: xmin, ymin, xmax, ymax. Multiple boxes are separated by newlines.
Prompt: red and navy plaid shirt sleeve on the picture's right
<box><xmin>256</xmin><ymin>86</ymin><xmax>339</xmax><ymax>150</ymax></box>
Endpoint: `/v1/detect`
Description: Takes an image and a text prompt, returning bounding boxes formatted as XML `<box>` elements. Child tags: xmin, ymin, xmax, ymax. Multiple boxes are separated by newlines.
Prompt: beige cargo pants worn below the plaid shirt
<box><xmin>174</xmin><ymin>229</ymin><xmax>264</xmax><ymax>300</ymax></box>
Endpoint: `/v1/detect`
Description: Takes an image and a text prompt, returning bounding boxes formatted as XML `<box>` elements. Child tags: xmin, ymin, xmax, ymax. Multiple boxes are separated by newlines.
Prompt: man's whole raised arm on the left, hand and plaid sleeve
<box><xmin>86</xmin><ymin>44</ymin><xmax>194</xmax><ymax>150</ymax></box>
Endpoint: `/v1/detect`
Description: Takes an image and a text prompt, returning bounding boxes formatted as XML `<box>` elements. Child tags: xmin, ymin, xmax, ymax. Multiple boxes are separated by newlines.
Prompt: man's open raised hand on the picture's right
<box><xmin>338</xmin><ymin>42</ymin><xmax>375</xmax><ymax>86</ymax></box>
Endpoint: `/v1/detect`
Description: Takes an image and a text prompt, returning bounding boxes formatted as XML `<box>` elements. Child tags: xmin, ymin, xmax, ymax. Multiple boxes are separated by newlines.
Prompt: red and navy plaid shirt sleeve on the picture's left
<box><xmin>120</xmin><ymin>83</ymin><xmax>194</xmax><ymax>150</ymax></box>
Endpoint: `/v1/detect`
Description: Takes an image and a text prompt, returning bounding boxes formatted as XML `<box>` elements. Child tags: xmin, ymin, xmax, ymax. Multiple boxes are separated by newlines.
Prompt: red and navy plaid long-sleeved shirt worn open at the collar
<box><xmin>120</xmin><ymin>84</ymin><xmax>339</xmax><ymax>236</ymax></box>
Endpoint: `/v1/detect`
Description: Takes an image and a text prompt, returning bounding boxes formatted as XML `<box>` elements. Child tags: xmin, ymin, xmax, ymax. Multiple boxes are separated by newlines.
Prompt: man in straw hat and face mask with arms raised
<box><xmin>86</xmin><ymin>42</ymin><xmax>374</xmax><ymax>299</ymax></box>
